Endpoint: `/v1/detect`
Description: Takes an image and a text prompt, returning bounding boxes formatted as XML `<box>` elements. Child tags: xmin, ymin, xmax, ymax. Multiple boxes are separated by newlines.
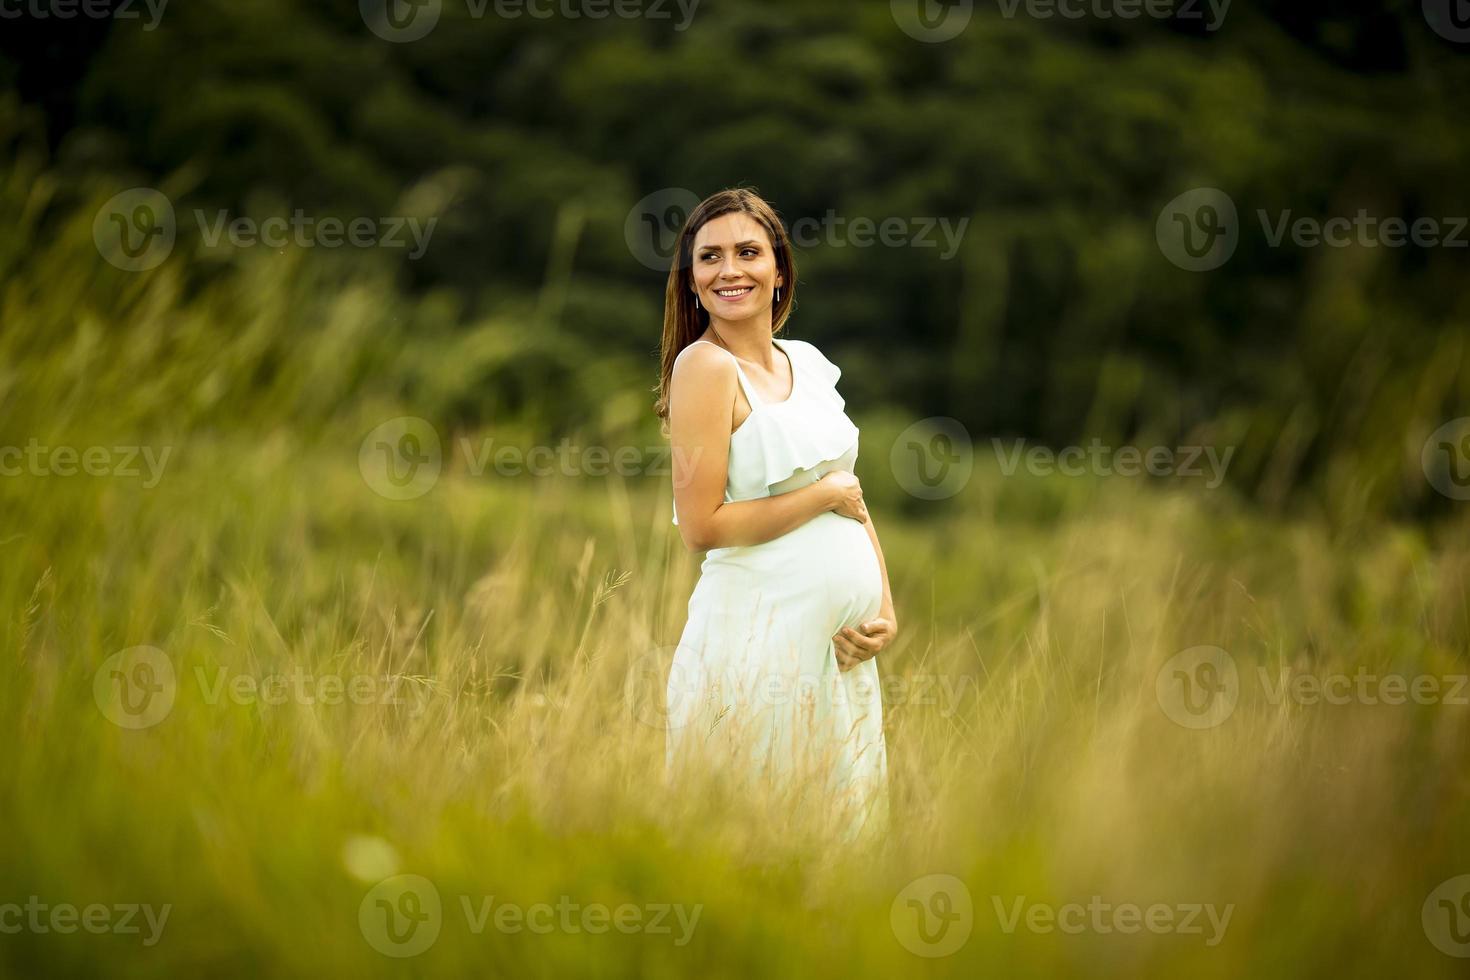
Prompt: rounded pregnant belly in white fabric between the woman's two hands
<box><xmin>697</xmin><ymin>511</ymin><xmax>883</xmax><ymax>636</ymax></box>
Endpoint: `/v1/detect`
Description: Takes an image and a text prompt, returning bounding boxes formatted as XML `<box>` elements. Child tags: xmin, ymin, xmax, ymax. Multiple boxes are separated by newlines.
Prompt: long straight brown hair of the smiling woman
<box><xmin>653</xmin><ymin>187</ymin><xmax>797</xmax><ymax>435</ymax></box>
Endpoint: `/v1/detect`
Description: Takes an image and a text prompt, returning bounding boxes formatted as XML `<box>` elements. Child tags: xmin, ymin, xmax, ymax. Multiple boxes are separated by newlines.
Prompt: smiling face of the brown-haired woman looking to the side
<box><xmin>692</xmin><ymin>212</ymin><xmax>785</xmax><ymax>320</ymax></box>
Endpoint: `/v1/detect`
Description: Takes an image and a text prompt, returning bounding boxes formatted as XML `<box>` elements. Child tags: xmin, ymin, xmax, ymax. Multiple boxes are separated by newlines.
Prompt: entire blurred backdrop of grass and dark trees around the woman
<box><xmin>0</xmin><ymin>0</ymin><xmax>1470</xmax><ymax>977</ymax></box>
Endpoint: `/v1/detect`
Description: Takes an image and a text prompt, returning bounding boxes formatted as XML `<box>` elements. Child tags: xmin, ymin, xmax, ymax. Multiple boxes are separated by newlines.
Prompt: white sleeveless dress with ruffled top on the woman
<box><xmin>666</xmin><ymin>338</ymin><xmax>888</xmax><ymax>839</ymax></box>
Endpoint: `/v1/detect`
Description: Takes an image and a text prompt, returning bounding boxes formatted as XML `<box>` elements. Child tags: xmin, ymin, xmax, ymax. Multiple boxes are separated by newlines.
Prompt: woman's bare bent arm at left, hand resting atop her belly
<box><xmin>669</xmin><ymin>344</ymin><xmax>866</xmax><ymax>551</ymax></box>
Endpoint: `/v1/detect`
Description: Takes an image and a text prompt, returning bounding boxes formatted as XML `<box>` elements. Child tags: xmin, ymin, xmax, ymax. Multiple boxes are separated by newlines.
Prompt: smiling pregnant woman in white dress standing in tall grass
<box><xmin>657</xmin><ymin>190</ymin><xmax>898</xmax><ymax>839</ymax></box>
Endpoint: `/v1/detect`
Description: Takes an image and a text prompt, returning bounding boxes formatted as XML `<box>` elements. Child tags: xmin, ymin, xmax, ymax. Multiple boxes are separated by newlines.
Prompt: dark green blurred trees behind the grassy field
<box><xmin>0</xmin><ymin>0</ymin><xmax>1470</xmax><ymax>520</ymax></box>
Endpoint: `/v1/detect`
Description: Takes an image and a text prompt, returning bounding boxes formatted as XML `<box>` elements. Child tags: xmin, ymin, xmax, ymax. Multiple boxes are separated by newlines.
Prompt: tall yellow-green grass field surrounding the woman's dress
<box><xmin>0</xmin><ymin>74</ymin><xmax>1470</xmax><ymax>977</ymax></box>
